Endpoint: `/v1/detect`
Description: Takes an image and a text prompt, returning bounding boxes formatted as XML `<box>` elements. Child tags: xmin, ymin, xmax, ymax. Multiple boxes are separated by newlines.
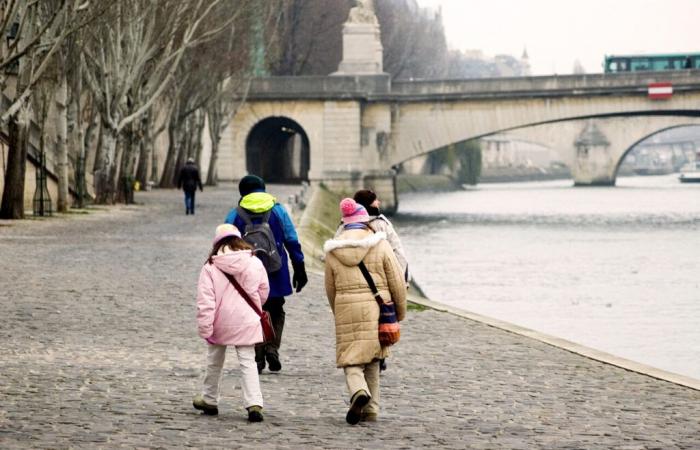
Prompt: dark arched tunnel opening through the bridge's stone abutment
<box><xmin>246</xmin><ymin>117</ymin><xmax>309</xmax><ymax>183</ymax></box>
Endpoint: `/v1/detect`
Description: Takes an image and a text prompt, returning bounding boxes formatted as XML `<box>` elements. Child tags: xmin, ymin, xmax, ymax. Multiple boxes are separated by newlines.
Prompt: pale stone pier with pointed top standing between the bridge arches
<box><xmin>572</xmin><ymin>120</ymin><xmax>617</xmax><ymax>186</ymax></box>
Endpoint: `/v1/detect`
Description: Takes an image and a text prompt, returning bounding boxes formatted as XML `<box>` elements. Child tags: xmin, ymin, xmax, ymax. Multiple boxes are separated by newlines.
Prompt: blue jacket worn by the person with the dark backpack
<box><xmin>225</xmin><ymin>197</ymin><xmax>304</xmax><ymax>298</ymax></box>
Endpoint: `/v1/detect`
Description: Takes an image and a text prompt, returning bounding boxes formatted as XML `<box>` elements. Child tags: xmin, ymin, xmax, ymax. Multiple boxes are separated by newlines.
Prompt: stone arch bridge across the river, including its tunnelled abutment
<box><xmin>219</xmin><ymin>70</ymin><xmax>700</xmax><ymax>214</ymax></box>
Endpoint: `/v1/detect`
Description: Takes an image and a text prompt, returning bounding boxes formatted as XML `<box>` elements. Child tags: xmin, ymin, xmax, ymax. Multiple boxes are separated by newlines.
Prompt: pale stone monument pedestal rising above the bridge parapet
<box><xmin>333</xmin><ymin>0</ymin><xmax>383</xmax><ymax>75</ymax></box>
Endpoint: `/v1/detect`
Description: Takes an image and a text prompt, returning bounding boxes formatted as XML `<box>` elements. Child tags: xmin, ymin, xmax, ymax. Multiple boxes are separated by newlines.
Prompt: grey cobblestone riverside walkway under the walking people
<box><xmin>0</xmin><ymin>185</ymin><xmax>700</xmax><ymax>449</ymax></box>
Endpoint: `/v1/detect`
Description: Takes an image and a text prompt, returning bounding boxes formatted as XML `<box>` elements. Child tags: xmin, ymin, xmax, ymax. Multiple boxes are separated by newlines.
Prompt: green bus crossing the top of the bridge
<box><xmin>604</xmin><ymin>53</ymin><xmax>700</xmax><ymax>73</ymax></box>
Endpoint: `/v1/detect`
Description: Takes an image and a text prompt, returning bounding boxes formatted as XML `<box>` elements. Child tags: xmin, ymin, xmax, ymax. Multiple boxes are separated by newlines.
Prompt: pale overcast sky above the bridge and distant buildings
<box><xmin>418</xmin><ymin>0</ymin><xmax>700</xmax><ymax>75</ymax></box>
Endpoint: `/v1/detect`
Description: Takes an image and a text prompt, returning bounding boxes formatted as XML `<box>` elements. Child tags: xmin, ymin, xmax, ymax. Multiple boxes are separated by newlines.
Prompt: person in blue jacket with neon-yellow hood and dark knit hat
<box><xmin>225</xmin><ymin>175</ymin><xmax>308</xmax><ymax>373</ymax></box>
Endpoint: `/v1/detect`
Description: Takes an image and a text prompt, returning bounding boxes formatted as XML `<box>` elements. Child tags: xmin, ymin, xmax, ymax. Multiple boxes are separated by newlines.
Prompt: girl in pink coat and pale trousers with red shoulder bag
<box><xmin>192</xmin><ymin>224</ymin><xmax>270</xmax><ymax>422</ymax></box>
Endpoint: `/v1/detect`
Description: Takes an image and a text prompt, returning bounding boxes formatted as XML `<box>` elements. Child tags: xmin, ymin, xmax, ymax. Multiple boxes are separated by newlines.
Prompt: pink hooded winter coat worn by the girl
<box><xmin>197</xmin><ymin>249</ymin><xmax>270</xmax><ymax>345</ymax></box>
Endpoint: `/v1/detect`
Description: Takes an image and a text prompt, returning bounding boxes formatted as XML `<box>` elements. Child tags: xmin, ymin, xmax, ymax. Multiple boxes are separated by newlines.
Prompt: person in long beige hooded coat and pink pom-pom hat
<box><xmin>323</xmin><ymin>198</ymin><xmax>406</xmax><ymax>425</ymax></box>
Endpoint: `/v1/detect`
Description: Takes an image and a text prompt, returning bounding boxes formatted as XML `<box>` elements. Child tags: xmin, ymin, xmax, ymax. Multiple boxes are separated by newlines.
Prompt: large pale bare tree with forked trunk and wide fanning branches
<box><xmin>84</xmin><ymin>0</ymin><xmax>230</xmax><ymax>203</ymax></box>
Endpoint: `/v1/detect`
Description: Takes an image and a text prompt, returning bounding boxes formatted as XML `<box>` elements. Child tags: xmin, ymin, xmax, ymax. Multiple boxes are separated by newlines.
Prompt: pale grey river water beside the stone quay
<box><xmin>393</xmin><ymin>175</ymin><xmax>700</xmax><ymax>380</ymax></box>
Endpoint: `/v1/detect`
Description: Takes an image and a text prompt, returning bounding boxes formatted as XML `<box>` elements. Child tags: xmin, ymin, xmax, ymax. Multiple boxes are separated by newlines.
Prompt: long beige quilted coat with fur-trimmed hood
<box><xmin>323</xmin><ymin>229</ymin><xmax>406</xmax><ymax>367</ymax></box>
